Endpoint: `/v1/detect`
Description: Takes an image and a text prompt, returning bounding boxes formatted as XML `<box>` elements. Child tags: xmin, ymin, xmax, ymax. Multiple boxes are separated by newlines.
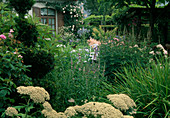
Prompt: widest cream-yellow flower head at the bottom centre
<box><xmin>74</xmin><ymin>102</ymin><xmax>123</xmax><ymax>118</ymax></box>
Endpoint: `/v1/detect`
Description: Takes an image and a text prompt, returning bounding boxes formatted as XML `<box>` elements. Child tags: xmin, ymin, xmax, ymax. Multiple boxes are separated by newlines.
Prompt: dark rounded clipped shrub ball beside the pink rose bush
<box><xmin>22</xmin><ymin>49</ymin><xmax>55</xmax><ymax>78</ymax></box>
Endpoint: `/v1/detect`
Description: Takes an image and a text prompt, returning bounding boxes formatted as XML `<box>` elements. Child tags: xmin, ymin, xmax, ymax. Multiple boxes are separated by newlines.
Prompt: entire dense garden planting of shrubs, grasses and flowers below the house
<box><xmin>0</xmin><ymin>0</ymin><xmax>170</xmax><ymax>118</ymax></box>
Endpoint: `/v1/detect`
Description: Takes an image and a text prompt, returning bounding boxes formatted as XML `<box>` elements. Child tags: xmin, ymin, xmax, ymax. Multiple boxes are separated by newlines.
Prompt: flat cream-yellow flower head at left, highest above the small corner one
<box><xmin>17</xmin><ymin>86</ymin><xmax>50</xmax><ymax>103</ymax></box>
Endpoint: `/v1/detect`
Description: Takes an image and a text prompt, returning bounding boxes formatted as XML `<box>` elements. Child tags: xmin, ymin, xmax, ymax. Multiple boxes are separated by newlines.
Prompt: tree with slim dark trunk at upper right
<box><xmin>112</xmin><ymin>0</ymin><xmax>170</xmax><ymax>40</ymax></box>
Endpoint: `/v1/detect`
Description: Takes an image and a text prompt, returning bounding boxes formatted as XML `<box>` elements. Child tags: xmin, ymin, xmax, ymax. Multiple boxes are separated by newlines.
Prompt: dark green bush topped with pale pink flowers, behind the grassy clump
<box><xmin>99</xmin><ymin>39</ymin><xmax>151</xmax><ymax>82</ymax></box>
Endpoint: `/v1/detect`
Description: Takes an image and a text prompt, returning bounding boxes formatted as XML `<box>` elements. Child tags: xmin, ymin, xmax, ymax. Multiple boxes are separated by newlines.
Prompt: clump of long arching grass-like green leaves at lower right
<box><xmin>110</xmin><ymin>59</ymin><xmax>170</xmax><ymax>118</ymax></box>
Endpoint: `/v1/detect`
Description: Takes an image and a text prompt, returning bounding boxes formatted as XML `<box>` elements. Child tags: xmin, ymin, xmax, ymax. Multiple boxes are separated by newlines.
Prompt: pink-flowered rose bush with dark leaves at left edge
<box><xmin>0</xmin><ymin>34</ymin><xmax>31</xmax><ymax>114</ymax></box>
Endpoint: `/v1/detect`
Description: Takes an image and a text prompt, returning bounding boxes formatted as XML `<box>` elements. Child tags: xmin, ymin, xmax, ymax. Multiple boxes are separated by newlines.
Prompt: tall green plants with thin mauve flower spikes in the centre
<box><xmin>34</xmin><ymin>46</ymin><xmax>104</xmax><ymax>111</ymax></box>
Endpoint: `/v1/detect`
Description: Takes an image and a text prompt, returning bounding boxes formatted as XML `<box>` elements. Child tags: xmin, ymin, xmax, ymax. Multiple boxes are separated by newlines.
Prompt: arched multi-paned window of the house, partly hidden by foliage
<box><xmin>33</xmin><ymin>7</ymin><xmax>56</xmax><ymax>35</ymax></box>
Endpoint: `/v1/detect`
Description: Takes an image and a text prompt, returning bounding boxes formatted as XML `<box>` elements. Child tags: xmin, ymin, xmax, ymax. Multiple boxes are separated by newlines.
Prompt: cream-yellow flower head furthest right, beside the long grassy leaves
<box><xmin>107</xmin><ymin>94</ymin><xmax>136</xmax><ymax>111</ymax></box>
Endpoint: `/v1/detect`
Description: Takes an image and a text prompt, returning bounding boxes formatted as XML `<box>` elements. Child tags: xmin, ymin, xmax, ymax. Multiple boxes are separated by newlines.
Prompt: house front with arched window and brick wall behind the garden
<box><xmin>29</xmin><ymin>0</ymin><xmax>77</xmax><ymax>33</ymax></box>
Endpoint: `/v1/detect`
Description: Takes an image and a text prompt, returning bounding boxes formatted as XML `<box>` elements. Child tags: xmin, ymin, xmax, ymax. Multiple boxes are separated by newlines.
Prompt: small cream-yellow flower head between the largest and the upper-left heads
<box><xmin>41</xmin><ymin>102</ymin><xmax>67</xmax><ymax>118</ymax></box>
